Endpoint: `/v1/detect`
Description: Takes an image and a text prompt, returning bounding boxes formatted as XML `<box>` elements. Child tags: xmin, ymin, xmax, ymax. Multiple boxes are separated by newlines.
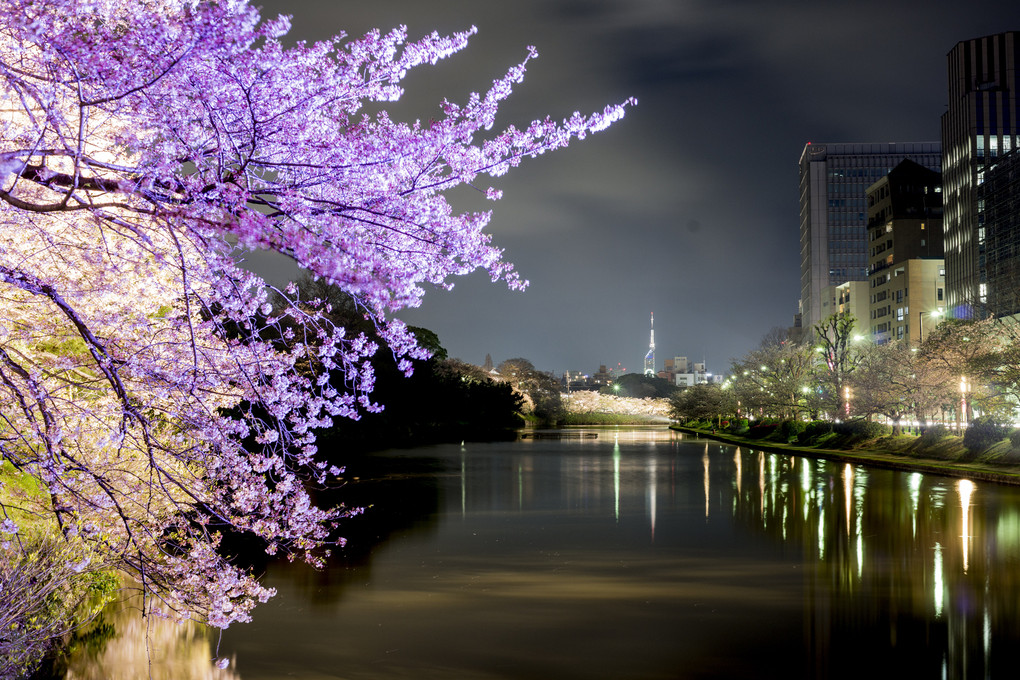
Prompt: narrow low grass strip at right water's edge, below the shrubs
<box><xmin>669</xmin><ymin>425</ymin><xmax>1020</xmax><ymax>486</ymax></box>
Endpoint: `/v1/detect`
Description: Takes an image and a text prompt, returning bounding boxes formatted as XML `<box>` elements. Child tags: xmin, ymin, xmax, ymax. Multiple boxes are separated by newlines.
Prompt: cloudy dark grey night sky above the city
<box><xmin>253</xmin><ymin>0</ymin><xmax>1020</xmax><ymax>374</ymax></box>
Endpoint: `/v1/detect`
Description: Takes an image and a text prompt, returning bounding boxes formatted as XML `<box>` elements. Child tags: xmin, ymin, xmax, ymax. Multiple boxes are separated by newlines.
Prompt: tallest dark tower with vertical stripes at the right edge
<box><xmin>942</xmin><ymin>31</ymin><xmax>1020</xmax><ymax>318</ymax></box>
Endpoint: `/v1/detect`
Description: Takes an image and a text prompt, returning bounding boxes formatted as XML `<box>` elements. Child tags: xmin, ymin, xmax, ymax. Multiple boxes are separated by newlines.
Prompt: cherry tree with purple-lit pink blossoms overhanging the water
<box><xmin>0</xmin><ymin>0</ymin><xmax>632</xmax><ymax>627</ymax></box>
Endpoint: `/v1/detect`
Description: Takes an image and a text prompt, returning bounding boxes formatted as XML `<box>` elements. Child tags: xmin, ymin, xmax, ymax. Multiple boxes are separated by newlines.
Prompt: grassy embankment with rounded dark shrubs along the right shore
<box><xmin>670</xmin><ymin>422</ymin><xmax>1020</xmax><ymax>485</ymax></box>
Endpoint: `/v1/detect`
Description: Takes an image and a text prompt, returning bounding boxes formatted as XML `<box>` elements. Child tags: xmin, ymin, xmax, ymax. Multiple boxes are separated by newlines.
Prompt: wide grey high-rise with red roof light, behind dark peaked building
<box><xmin>801</xmin><ymin>142</ymin><xmax>941</xmax><ymax>332</ymax></box>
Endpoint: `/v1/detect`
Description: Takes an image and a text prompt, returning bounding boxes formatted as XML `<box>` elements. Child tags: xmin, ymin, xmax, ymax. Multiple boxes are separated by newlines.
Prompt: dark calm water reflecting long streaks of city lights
<box><xmin>59</xmin><ymin>429</ymin><xmax>1020</xmax><ymax>680</ymax></box>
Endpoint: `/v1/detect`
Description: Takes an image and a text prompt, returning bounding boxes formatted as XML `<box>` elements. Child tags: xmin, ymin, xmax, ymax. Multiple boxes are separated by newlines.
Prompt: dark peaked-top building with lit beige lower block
<box><xmin>862</xmin><ymin>160</ymin><xmax>946</xmax><ymax>347</ymax></box>
